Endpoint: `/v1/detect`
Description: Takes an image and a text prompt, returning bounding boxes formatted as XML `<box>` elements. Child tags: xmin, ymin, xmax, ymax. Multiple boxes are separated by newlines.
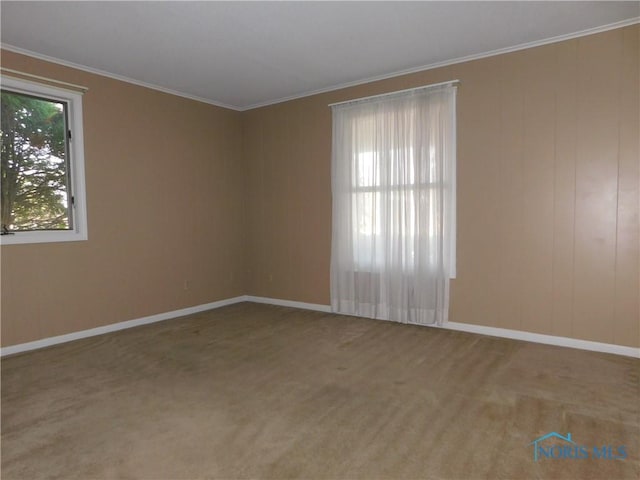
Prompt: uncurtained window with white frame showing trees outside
<box><xmin>0</xmin><ymin>77</ymin><xmax>87</xmax><ymax>244</ymax></box>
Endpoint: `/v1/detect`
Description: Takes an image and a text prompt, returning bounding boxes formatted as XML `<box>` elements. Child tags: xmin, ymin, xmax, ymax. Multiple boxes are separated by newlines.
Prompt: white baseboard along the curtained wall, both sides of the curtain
<box><xmin>247</xmin><ymin>296</ymin><xmax>640</xmax><ymax>358</ymax></box>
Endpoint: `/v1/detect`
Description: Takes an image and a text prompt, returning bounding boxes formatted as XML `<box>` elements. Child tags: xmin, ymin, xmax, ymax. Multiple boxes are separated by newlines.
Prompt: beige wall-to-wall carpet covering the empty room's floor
<box><xmin>1</xmin><ymin>303</ymin><xmax>640</xmax><ymax>480</ymax></box>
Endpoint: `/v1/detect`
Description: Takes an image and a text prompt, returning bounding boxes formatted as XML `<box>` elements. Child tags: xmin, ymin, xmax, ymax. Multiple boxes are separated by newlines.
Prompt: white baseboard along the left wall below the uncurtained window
<box><xmin>0</xmin><ymin>295</ymin><xmax>247</xmax><ymax>357</ymax></box>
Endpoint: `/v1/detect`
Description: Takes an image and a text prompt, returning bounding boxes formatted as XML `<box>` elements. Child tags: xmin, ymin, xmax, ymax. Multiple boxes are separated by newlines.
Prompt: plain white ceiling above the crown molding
<box><xmin>0</xmin><ymin>1</ymin><xmax>640</xmax><ymax>110</ymax></box>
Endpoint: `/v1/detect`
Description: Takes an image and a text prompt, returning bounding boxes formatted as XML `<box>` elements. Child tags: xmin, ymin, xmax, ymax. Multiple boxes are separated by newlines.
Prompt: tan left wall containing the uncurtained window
<box><xmin>1</xmin><ymin>51</ymin><xmax>245</xmax><ymax>345</ymax></box>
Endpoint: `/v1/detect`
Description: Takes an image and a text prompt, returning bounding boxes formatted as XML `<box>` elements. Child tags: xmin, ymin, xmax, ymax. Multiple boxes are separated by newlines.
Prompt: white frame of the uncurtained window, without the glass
<box><xmin>0</xmin><ymin>76</ymin><xmax>89</xmax><ymax>245</ymax></box>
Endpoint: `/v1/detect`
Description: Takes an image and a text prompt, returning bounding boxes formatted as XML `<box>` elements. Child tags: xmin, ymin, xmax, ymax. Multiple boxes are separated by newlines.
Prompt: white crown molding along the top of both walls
<box><xmin>0</xmin><ymin>17</ymin><xmax>640</xmax><ymax>112</ymax></box>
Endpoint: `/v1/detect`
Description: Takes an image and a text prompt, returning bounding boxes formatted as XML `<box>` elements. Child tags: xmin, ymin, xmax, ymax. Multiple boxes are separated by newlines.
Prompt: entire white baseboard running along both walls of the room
<box><xmin>0</xmin><ymin>295</ymin><xmax>640</xmax><ymax>358</ymax></box>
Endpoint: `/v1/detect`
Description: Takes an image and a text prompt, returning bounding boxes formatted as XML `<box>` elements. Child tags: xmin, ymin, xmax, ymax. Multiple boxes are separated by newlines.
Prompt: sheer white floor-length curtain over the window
<box><xmin>331</xmin><ymin>84</ymin><xmax>456</xmax><ymax>324</ymax></box>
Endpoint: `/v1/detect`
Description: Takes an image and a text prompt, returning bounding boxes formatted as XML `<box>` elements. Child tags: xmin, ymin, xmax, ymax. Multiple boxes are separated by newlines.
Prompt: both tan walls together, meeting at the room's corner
<box><xmin>2</xmin><ymin>25</ymin><xmax>640</xmax><ymax>346</ymax></box>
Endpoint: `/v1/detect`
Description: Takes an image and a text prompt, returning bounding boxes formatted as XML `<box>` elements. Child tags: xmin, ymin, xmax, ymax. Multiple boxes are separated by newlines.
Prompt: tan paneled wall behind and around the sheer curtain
<box><xmin>243</xmin><ymin>25</ymin><xmax>640</xmax><ymax>346</ymax></box>
